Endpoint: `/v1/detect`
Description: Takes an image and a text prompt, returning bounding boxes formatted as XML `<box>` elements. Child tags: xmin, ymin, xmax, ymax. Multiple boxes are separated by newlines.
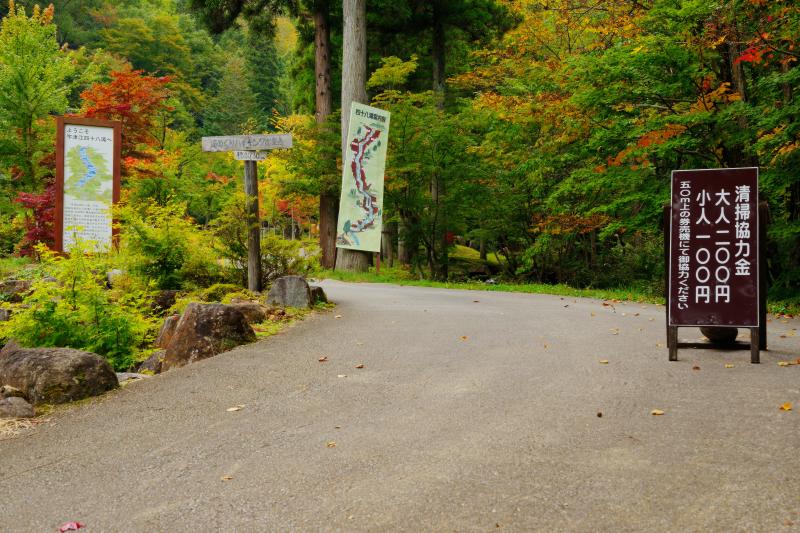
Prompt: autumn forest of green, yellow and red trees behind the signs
<box><xmin>0</xmin><ymin>0</ymin><xmax>800</xmax><ymax>312</ymax></box>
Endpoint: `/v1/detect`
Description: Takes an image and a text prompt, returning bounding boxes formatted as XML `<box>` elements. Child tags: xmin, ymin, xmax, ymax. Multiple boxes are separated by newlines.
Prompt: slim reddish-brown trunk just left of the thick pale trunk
<box><xmin>314</xmin><ymin>1</ymin><xmax>339</xmax><ymax>268</ymax></box>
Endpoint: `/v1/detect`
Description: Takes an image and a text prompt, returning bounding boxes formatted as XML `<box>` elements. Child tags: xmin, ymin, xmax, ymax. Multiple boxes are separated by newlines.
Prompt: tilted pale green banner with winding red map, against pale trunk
<box><xmin>336</xmin><ymin>102</ymin><xmax>390</xmax><ymax>252</ymax></box>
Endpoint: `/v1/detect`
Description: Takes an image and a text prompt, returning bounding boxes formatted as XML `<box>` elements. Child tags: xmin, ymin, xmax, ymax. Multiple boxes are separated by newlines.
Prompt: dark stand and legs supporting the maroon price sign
<box><xmin>664</xmin><ymin>202</ymin><xmax>769</xmax><ymax>364</ymax></box>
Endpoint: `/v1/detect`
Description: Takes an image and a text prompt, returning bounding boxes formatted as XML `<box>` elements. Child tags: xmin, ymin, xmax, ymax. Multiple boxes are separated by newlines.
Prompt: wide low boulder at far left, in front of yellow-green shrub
<box><xmin>0</xmin><ymin>342</ymin><xmax>119</xmax><ymax>405</ymax></box>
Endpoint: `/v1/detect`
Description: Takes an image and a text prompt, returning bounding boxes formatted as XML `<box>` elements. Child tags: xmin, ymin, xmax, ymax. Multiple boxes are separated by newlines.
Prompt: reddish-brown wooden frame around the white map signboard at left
<box><xmin>54</xmin><ymin>117</ymin><xmax>122</xmax><ymax>252</ymax></box>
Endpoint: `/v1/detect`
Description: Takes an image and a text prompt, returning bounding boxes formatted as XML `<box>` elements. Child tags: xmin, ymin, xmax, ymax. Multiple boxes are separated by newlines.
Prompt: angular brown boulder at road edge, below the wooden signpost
<box><xmin>161</xmin><ymin>303</ymin><xmax>256</xmax><ymax>371</ymax></box>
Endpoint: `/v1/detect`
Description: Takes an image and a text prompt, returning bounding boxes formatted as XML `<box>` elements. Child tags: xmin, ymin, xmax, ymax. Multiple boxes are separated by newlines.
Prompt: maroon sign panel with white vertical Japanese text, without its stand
<box><xmin>669</xmin><ymin>168</ymin><xmax>759</xmax><ymax>327</ymax></box>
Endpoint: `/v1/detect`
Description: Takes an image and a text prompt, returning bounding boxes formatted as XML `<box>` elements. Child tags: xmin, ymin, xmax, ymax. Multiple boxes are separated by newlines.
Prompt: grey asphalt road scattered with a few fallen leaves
<box><xmin>0</xmin><ymin>282</ymin><xmax>800</xmax><ymax>532</ymax></box>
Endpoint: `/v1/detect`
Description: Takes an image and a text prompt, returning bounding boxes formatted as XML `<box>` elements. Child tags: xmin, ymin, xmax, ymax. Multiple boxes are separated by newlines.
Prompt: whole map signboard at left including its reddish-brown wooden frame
<box><xmin>55</xmin><ymin>117</ymin><xmax>121</xmax><ymax>252</ymax></box>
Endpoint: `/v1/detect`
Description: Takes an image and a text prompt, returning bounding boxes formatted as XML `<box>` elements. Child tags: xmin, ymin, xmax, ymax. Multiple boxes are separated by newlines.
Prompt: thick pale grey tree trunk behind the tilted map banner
<box><xmin>336</xmin><ymin>0</ymin><xmax>371</xmax><ymax>272</ymax></box>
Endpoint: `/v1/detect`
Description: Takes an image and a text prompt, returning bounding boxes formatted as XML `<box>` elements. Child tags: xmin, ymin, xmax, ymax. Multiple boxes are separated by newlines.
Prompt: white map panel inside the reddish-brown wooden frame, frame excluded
<box><xmin>63</xmin><ymin>124</ymin><xmax>114</xmax><ymax>251</ymax></box>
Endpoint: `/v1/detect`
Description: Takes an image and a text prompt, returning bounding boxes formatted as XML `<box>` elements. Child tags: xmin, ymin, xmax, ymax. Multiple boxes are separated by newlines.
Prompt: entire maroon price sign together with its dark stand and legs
<box><xmin>663</xmin><ymin>168</ymin><xmax>769</xmax><ymax>363</ymax></box>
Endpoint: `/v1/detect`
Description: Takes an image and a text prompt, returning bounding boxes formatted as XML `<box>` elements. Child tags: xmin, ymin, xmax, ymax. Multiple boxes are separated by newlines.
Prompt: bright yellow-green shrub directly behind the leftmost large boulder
<box><xmin>0</xmin><ymin>243</ymin><xmax>154</xmax><ymax>371</ymax></box>
